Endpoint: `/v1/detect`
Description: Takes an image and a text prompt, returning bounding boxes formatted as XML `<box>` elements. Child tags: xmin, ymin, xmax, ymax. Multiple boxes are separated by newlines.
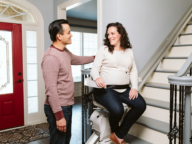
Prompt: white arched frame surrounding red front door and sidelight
<box><xmin>0</xmin><ymin>0</ymin><xmax>46</xmax><ymax>129</ymax></box>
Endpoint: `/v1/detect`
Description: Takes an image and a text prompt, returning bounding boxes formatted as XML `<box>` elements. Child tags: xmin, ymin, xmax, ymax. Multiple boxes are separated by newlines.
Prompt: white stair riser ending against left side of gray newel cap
<box><xmin>147</xmin><ymin>72</ymin><xmax>175</xmax><ymax>84</ymax></box>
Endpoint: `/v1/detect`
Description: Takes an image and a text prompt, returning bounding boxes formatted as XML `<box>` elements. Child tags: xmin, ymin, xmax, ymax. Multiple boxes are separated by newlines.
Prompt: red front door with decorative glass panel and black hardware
<box><xmin>0</xmin><ymin>23</ymin><xmax>24</xmax><ymax>130</ymax></box>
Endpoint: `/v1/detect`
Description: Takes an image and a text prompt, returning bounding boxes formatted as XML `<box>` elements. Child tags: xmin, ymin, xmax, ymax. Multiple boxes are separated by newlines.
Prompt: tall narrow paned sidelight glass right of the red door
<box><xmin>26</xmin><ymin>31</ymin><xmax>38</xmax><ymax>114</ymax></box>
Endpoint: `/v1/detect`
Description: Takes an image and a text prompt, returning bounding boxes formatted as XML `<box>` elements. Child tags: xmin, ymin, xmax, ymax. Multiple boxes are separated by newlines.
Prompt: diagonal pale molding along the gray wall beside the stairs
<box><xmin>139</xmin><ymin>6</ymin><xmax>192</xmax><ymax>90</ymax></box>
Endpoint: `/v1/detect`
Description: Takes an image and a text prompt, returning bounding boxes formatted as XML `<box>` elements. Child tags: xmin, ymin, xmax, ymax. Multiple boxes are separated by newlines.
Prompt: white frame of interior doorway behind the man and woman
<box><xmin>57</xmin><ymin>0</ymin><xmax>103</xmax><ymax>49</ymax></box>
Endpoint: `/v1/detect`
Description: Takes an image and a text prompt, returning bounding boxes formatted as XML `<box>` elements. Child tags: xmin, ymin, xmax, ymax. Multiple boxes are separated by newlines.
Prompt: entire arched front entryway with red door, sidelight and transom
<box><xmin>0</xmin><ymin>0</ymin><xmax>46</xmax><ymax>130</ymax></box>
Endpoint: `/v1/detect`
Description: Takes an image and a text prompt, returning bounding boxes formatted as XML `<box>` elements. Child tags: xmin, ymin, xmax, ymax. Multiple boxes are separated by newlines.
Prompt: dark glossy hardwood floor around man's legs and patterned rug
<box><xmin>27</xmin><ymin>97</ymin><xmax>81</xmax><ymax>144</ymax></box>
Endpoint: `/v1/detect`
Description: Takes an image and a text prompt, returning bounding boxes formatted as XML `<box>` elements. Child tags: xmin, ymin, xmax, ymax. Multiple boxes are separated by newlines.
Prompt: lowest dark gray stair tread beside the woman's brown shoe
<box><xmin>124</xmin><ymin>134</ymin><xmax>152</xmax><ymax>144</ymax></box>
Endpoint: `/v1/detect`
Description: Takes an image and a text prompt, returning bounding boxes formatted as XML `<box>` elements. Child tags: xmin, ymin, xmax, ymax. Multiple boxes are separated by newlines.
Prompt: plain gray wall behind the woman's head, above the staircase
<box><xmin>102</xmin><ymin>0</ymin><xmax>192</xmax><ymax>71</ymax></box>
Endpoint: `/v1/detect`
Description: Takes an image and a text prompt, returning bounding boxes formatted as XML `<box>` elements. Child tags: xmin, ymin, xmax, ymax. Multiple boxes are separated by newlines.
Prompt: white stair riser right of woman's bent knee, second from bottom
<box><xmin>142</xmin><ymin>105</ymin><xmax>192</xmax><ymax>124</ymax></box>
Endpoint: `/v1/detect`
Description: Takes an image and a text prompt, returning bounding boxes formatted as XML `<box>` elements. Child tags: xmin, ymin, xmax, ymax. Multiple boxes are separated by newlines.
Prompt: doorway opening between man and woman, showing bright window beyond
<box><xmin>66</xmin><ymin>0</ymin><xmax>98</xmax><ymax>97</ymax></box>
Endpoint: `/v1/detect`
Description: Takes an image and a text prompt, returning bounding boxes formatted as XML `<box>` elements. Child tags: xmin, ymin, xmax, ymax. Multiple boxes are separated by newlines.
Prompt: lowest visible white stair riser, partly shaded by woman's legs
<box><xmin>129</xmin><ymin>124</ymin><xmax>178</xmax><ymax>144</ymax></box>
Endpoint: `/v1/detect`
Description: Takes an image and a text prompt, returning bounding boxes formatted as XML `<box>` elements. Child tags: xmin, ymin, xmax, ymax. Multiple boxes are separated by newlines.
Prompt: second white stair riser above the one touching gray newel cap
<box><xmin>165</xmin><ymin>46</ymin><xmax>192</xmax><ymax>57</ymax></box>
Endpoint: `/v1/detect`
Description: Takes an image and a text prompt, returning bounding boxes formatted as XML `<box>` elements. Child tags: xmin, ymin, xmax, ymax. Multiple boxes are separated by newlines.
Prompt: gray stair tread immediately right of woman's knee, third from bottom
<box><xmin>144</xmin><ymin>97</ymin><xmax>192</xmax><ymax>114</ymax></box>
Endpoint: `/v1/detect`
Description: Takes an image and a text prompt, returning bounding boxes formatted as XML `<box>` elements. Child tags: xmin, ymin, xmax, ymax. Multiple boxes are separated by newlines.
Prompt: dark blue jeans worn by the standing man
<box><xmin>44</xmin><ymin>105</ymin><xmax>72</xmax><ymax>144</ymax></box>
